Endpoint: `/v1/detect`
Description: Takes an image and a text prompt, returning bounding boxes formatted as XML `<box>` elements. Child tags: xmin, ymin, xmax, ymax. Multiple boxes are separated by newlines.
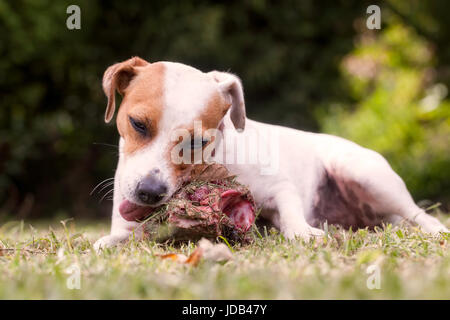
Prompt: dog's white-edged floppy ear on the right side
<box><xmin>208</xmin><ymin>71</ymin><xmax>245</xmax><ymax>132</ymax></box>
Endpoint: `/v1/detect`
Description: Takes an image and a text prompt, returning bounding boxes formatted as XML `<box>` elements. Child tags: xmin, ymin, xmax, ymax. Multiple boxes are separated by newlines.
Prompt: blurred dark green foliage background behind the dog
<box><xmin>0</xmin><ymin>0</ymin><xmax>450</xmax><ymax>218</ymax></box>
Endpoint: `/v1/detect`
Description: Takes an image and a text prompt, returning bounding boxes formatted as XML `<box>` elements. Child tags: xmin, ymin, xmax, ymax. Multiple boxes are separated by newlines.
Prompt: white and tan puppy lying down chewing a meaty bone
<box><xmin>94</xmin><ymin>57</ymin><xmax>448</xmax><ymax>250</ymax></box>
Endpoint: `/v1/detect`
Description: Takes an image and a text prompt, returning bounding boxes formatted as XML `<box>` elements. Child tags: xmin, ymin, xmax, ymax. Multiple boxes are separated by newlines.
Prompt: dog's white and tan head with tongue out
<box><xmin>103</xmin><ymin>57</ymin><xmax>245</xmax><ymax>205</ymax></box>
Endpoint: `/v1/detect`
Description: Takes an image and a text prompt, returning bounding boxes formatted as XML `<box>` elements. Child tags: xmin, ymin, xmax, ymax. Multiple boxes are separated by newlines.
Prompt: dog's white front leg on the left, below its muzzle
<box><xmin>94</xmin><ymin>178</ymin><xmax>144</xmax><ymax>251</ymax></box>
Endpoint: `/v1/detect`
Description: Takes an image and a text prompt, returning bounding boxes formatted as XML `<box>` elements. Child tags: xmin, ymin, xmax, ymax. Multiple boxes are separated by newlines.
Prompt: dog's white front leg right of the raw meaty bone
<box><xmin>275</xmin><ymin>185</ymin><xmax>324</xmax><ymax>240</ymax></box>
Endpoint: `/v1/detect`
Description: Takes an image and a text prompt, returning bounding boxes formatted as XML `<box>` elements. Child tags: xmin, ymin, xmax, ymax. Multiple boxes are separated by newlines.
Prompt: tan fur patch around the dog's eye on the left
<box><xmin>117</xmin><ymin>62</ymin><xmax>165</xmax><ymax>154</ymax></box>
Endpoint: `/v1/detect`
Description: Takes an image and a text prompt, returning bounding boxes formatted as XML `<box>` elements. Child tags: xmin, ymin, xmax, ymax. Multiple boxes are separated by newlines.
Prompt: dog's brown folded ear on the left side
<box><xmin>103</xmin><ymin>57</ymin><xmax>148</xmax><ymax>122</ymax></box>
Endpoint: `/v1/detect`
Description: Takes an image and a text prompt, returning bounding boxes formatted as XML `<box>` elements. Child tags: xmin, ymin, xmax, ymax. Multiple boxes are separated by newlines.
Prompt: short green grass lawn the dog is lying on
<box><xmin>0</xmin><ymin>215</ymin><xmax>450</xmax><ymax>299</ymax></box>
